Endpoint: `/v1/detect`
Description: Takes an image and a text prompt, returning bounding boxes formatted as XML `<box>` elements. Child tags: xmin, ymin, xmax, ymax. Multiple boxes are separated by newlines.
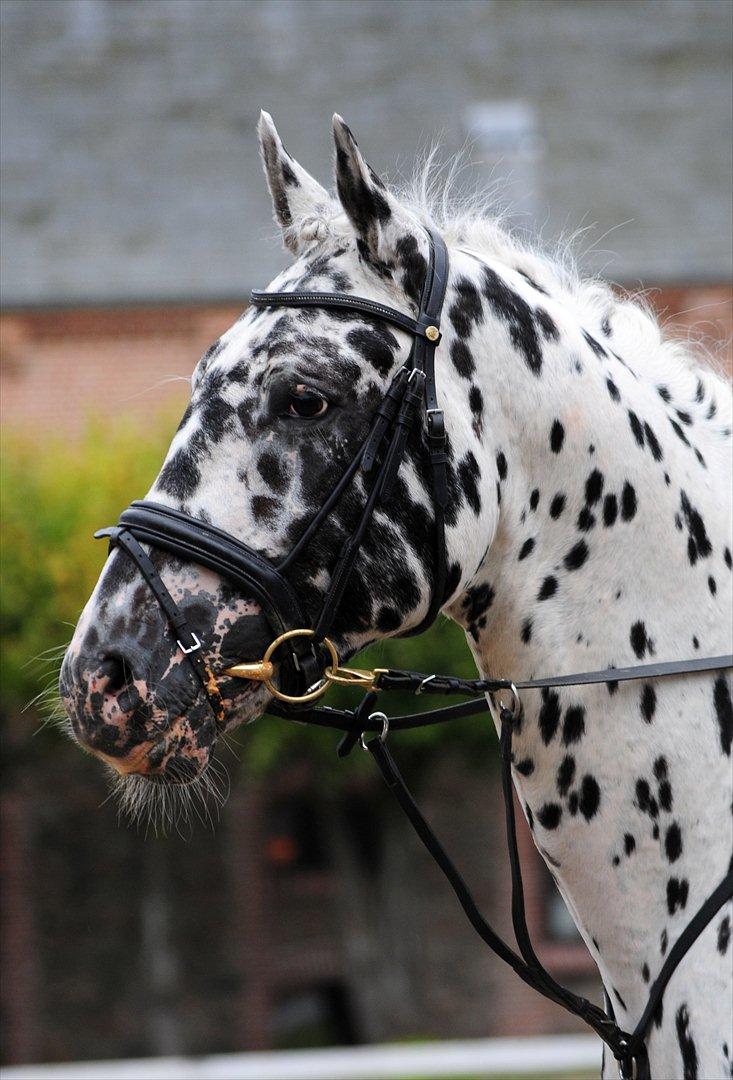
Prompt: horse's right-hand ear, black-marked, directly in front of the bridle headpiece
<box><xmin>334</xmin><ymin>113</ymin><xmax>427</xmax><ymax>302</ymax></box>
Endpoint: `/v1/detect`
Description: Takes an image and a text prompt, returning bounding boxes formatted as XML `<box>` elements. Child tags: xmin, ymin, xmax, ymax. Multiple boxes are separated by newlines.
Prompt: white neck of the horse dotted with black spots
<box><xmin>442</xmin><ymin>250</ymin><xmax>732</xmax><ymax>1076</ymax></box>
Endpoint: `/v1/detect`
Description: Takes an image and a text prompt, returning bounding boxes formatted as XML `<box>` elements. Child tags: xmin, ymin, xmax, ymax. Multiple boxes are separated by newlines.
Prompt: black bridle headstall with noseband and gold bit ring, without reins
<box><xmin>95</xmin><ymin>224</ymin><xmax>448</xmax><ymax>718</ymax></box>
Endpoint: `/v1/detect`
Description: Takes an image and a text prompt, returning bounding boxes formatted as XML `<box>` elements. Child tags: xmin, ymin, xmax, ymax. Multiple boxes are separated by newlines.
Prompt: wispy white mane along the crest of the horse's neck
<box><xmin>397</xmin><ymin>151</ymin><xmax>731</xmax><ymax>406</ymax></box>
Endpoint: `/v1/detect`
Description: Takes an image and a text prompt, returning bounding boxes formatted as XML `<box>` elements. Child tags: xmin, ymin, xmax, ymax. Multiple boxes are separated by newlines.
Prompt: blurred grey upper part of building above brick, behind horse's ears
<box><xmin>1</xmin><ymin>0</ymin><xmax>732</xmax><ymax>305</ymax></box>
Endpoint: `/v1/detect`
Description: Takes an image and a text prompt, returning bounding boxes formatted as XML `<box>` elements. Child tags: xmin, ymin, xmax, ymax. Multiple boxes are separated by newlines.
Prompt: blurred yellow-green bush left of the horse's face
<box><xmin>0</xmin><ymin>420</ymin><xmax>172</xmax><ymax>711</ymax></box>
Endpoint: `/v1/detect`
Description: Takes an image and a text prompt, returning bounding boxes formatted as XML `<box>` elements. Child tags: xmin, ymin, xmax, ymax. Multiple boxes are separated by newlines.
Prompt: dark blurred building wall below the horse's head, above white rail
<box><xmin>0</xmin><ymin>743</ymin><xmax>599</xmax><ymax>1064</ymax></box>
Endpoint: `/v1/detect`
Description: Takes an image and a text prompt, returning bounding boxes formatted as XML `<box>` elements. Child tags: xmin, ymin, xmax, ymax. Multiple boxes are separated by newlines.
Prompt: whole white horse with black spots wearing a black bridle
<box><xmin>60</xmin><ymin>113</ymin><xmax>733</xmax><ymax>1078</ymax></box>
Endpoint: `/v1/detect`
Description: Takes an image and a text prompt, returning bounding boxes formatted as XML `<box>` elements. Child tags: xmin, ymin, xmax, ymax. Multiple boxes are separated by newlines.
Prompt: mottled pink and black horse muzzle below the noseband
<box><xmin>60</xmin><ymin>552</ymin><xmax>271</xmax><ymax>783</ymax></box>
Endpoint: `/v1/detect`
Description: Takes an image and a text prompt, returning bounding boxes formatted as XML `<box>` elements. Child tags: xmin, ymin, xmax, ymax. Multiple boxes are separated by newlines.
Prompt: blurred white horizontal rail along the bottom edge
<box><xmin>0</xmin><ymin>1035</ymin><xmax>600</xmax><ymax>1080</ymax></box>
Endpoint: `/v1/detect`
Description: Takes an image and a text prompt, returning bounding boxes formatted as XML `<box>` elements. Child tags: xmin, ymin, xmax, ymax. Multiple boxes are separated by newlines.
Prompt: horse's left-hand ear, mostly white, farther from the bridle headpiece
<box><xmin>257</xmin><ymin>112</ymin><xmax>332</xmax><ymax>255</ymax></box>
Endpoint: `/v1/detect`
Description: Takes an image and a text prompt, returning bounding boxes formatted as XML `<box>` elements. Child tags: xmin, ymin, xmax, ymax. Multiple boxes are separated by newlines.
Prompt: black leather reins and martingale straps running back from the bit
<box><xmin>268</xmin><ymin>643</ymin><xmax>733</xmax><ymax>1080</ymax></box>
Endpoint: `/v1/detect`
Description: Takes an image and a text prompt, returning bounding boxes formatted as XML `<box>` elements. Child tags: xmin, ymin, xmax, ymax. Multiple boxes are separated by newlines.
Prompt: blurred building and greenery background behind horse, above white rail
<box><xmin>0</xmin><ymin>0</ymin><xmax>733</xmax><ymax>1063</ymax></box>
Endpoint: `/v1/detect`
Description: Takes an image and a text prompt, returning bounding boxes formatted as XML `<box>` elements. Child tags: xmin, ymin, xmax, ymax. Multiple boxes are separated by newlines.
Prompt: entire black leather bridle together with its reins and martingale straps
<box><xmin>95</xmin><ymin>228</ymin><xmax>733</xmax><ymax>1080</ymax></box>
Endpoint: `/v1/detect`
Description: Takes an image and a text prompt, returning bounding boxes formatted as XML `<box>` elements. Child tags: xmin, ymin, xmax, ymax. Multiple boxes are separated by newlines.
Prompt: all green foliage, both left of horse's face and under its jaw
<box><xmin>0</xmin><ymin>418</ymin><xmax>492</xmax><ymax>773</ymax></box>
